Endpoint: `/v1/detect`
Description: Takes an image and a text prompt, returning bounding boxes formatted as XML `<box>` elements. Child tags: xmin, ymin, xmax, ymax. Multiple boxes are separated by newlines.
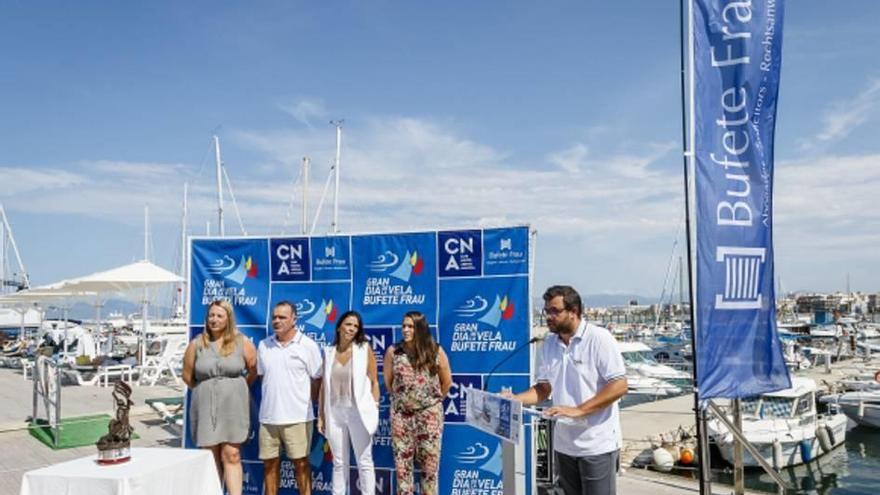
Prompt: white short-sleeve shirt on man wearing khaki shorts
<box><xmin>257</xmin><ymin>331</ymin><xmax>323</xmax><ymax>425</ymax></box>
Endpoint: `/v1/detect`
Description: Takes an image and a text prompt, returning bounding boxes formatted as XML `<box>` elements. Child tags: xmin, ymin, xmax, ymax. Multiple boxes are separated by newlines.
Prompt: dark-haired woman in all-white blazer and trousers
<box><xmin>318</xmin><ymin>311</ymin><xmax>379</xmax><ymax>495</ymax></box>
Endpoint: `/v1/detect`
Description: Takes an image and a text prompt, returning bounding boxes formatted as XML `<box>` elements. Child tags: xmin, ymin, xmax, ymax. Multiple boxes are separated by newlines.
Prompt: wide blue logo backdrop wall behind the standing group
<box><xmin>184</xmin><ymin>226</ymin><xmax>531</xmax><ymax>495</ymax></box>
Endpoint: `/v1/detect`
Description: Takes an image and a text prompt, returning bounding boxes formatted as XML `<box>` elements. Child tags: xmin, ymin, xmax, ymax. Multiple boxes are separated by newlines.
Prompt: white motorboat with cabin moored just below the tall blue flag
<box><xmin>707</xmin><ymin>377</ymin><xmax>847</xmax><ymax>469</ymax></box>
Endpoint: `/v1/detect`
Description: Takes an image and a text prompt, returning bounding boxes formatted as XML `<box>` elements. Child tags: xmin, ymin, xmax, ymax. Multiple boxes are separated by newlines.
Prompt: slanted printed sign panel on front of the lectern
<box><xmin>465</xmin><ymin>388</ymin><xmax>522</xmax><ymax>443</ymax></box>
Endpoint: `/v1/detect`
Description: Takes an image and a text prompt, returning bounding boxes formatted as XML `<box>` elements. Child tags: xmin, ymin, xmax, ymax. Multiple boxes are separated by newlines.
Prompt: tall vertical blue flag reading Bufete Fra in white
<box><xmin>691</xmin><ymin>0</ymin><xmax>791</xmax><ymax>399</ymax></box>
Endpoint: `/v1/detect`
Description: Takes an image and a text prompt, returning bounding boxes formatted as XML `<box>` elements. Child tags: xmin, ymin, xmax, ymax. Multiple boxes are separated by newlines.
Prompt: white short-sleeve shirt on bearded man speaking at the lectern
<box><xmin>537</xmin><ymin>320</ymin><xmax>626</xmax><ymax>457</ymax></box>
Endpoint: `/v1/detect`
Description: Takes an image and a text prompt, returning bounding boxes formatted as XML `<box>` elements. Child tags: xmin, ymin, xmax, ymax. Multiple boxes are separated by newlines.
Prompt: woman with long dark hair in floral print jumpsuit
<box><xmin>383</xmin><ymin>311</ymin><xmax>452</xmax><ymax>495</ymax></box>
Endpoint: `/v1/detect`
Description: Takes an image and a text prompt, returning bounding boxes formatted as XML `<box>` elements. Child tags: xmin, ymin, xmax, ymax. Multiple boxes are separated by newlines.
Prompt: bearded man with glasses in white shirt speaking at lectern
<box><xmin>508</xmin><ymin>285</ymin><xmax>627</xmax><ymax>495</ymax></box>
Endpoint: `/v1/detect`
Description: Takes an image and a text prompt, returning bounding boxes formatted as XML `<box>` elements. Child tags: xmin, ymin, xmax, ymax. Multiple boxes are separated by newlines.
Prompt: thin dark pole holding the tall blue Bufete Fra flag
<box><xmin>679</xmin><ymin>0</ymin><xmax>712</xmax><ymax>495</ymax></box>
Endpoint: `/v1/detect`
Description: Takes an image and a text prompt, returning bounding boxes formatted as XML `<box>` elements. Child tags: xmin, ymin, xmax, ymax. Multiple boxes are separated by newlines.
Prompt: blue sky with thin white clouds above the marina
<box><xmin>0</xmin><ymin>0</ymin><xmax>880</xmax><ymax>306</ymax></box>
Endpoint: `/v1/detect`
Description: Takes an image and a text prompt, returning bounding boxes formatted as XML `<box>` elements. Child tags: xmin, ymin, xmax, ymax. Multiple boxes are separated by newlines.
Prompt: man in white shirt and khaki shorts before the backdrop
<box><xmin>257</xmin><ymin>301</ymin><xmax>323</xmax><ymax>495</ymax></box>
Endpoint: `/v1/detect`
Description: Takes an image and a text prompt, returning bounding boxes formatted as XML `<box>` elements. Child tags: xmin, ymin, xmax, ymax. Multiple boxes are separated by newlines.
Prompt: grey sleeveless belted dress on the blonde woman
<box><xmin>190</xmin><ymin>336</ymin><xmax>250</xmax><ymax>447</ymax></box>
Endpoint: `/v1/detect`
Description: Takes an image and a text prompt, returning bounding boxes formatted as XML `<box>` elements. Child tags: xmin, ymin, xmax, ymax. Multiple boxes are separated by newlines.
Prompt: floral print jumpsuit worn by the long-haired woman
<box><xmin>391</xmin><ymin>348</ymin><xmax>443</xmax><ymax>495</ymax></box>
